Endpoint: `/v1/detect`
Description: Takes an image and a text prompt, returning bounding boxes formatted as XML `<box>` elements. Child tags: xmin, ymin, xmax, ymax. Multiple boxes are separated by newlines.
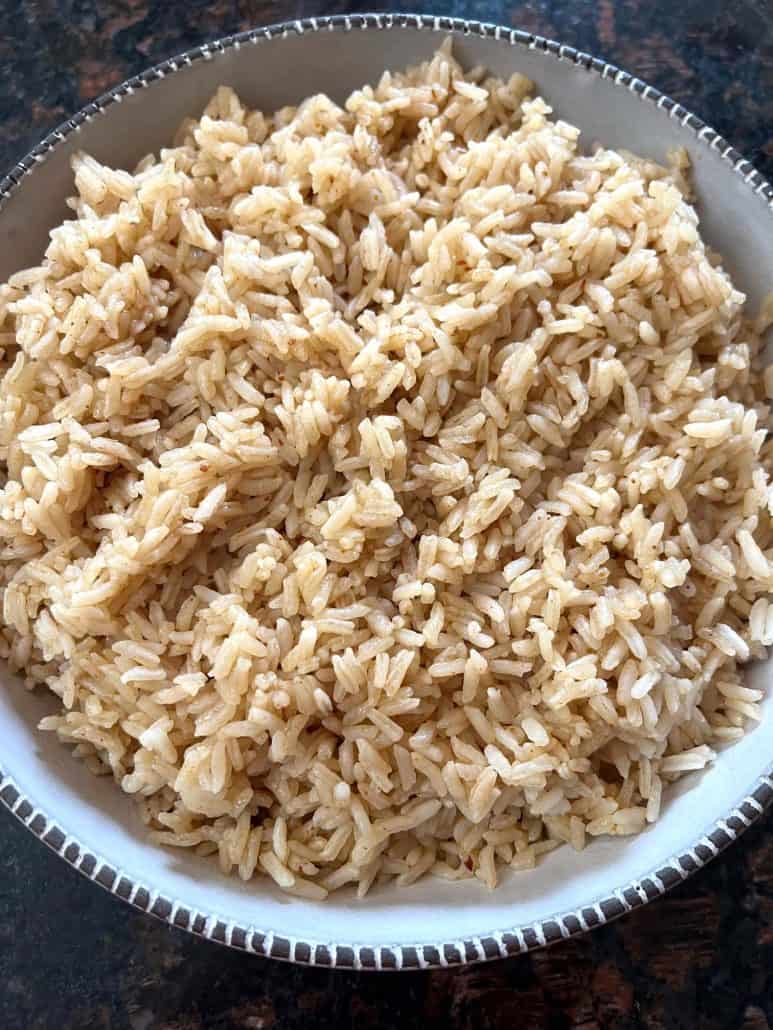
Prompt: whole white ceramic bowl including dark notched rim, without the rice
<box><xmin>0</xmin><ymin>14</ymin><xmax>773</xmax><ymax>968</ymax></box>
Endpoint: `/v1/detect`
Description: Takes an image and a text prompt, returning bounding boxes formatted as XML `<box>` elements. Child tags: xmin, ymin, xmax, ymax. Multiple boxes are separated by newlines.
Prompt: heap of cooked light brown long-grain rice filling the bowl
<box><xmin>0</xmin><ymin>47</ymin><xmax>773</xmax><ymax>898</ymax></box>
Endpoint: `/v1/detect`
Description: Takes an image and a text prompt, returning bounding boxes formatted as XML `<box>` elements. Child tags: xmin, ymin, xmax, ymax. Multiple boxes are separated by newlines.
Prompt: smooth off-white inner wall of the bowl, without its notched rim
<box><xmin>0</xmin><ymin>25</ymin><xmax>773</xmax><ymax>947</ymax></box>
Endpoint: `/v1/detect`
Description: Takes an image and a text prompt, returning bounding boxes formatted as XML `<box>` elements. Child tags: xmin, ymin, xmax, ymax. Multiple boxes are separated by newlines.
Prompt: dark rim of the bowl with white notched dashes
<box><xmin>0</xmin><ymin>13</ymin><xmax>773</xmax><ymax>970</ymax></box>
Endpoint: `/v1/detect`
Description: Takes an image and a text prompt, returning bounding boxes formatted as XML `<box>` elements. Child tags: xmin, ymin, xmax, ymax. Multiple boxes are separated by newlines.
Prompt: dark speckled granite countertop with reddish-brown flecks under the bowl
<box><xmin>0</xmin><ymin>0</ymin><xmax>773</xmax><ymax>1030</ymax></box>
